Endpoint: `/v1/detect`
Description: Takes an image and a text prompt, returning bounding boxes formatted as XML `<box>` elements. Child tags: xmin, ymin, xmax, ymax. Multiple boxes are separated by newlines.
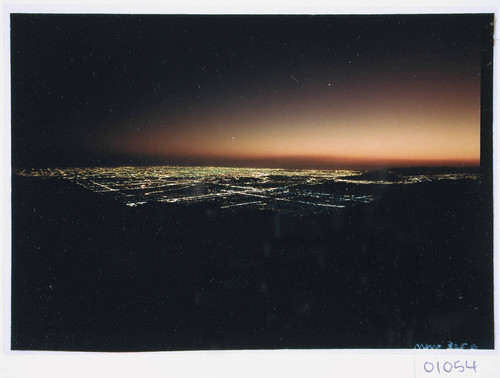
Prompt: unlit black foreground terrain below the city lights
<box><xmin>12</xmin><ymin>176</ymin><xmax>493</xmax><ymax>351</ymax></box>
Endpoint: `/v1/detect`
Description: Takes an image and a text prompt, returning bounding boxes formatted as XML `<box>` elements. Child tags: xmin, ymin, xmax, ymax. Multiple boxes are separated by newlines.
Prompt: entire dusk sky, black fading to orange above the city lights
<box><xmin>11</xmin><ymin>14</ymin><xmax>491</xmax><ymax>168</ymax></box>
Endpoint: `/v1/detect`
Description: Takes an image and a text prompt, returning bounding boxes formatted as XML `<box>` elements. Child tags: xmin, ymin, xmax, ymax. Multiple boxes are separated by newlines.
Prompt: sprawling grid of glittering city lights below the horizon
<box><xmin>17</xmin><ymin>166</ymin><xmax>476</xmax><ymax>214</ymax></box>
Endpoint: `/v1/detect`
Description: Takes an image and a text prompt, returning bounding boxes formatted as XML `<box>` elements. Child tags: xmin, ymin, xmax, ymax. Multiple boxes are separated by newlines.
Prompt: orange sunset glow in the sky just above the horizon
<box><xmin>98</xmin><ymin>71</ymin><xmax>480</xmax><ymax>167</ymax></box>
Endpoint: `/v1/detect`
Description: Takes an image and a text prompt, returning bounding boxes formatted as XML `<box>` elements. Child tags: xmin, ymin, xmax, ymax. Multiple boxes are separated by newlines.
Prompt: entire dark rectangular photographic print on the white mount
<box><xmin>10</xmin><ymin>13</ymin><xmax>494</xmax><ymax>352</ymax></box>
